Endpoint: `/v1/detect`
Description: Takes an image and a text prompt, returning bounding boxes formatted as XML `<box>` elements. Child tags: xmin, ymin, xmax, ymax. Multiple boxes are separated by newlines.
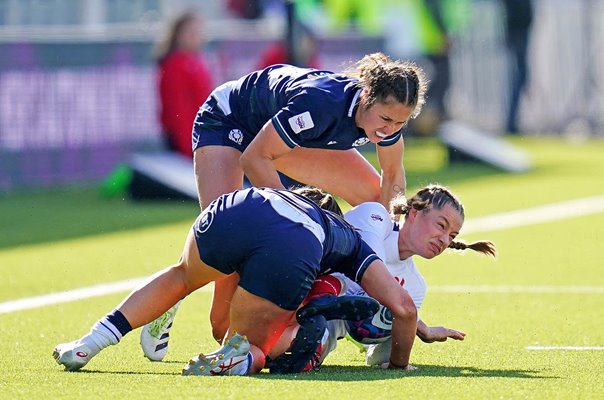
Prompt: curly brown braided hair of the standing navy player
<box><xmin>347</xmin><ymin>53</ymin><xmax>428</xmax><ymax>118</ymax></box>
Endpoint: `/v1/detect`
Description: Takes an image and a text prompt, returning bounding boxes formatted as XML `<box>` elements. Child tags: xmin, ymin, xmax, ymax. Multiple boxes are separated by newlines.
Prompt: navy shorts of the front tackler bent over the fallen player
<box><xmin>193</xmin><ymin>189</ymin><xmax>323</xmax><ymax>310</ymax></box>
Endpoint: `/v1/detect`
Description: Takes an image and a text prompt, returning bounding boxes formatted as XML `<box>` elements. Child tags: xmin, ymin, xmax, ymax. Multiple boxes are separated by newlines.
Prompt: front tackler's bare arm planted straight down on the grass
<box><xmin>361</xmin><ymin>259</ymin><xmax>417</xmax><ymax>369</ymax></box>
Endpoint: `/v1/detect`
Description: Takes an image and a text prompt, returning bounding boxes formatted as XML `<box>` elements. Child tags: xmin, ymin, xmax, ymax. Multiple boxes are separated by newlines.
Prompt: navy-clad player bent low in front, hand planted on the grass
<box><xmin>53</xmin><ymin>188</ymin><xmax>417</xmax><ymax>375</ymax></box>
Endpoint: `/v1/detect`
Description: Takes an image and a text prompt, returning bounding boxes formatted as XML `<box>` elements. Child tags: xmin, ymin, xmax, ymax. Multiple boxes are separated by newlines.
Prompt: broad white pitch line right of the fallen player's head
<box><xmin>462</xmin><ymin>196</ymin><xmax>604</xmax><ymax>234</ymax></box>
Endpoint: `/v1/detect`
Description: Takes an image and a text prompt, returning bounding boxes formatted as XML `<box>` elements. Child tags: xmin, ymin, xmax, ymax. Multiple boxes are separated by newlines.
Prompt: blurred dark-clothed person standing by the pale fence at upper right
<box><xmin>503</xmin><ymin>0</ymin><xmax>533</xmax><ymax>133</ymax></box>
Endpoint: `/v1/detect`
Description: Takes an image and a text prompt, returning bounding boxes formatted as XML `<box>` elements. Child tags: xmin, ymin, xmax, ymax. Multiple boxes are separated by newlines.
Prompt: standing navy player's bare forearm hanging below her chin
<box><xmin>376</xmin><ymin>137</ymin><xmax>407</xmax><ymax>209</ymax></box>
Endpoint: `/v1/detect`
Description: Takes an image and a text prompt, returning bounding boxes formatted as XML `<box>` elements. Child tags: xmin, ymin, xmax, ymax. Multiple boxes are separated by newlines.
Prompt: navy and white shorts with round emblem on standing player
<box><xmin>192</xmin><ymin>82</ymin><xmax>258</xmax><ymax>153</ymax></box>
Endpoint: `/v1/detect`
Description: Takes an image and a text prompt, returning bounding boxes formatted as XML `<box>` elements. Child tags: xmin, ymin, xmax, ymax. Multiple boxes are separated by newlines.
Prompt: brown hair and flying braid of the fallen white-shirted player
<box><xmin>390</xmin><ymin>184</ymin><xmax>497</xmax><ymax>257</ymax></box>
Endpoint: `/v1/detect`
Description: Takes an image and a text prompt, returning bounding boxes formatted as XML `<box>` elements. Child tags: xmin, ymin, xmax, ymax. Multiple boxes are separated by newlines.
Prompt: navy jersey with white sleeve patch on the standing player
<box><xmin>229</xmin><ymin>64</ymin><xmax>401</xmax><ymax>150</ymax></box>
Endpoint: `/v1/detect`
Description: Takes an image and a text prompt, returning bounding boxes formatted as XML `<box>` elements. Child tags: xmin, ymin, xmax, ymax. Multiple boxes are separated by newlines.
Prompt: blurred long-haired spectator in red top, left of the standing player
<box><xmin>155</xmin><ymin>11</ymin><xmax>213</xmax><ymax>158</ymax></box>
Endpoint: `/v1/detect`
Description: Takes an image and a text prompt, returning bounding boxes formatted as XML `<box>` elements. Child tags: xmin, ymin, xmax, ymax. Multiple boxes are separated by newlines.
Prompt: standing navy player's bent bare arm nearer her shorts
<box><xmin>239</xmin><ymin>121</ymin><xmax>291</xmax><ymax>189</ymax></box>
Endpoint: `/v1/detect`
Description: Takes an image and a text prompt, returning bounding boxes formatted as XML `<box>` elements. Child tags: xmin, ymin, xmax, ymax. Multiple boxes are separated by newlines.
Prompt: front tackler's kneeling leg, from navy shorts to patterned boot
<box><xmin>183</xmin><ymin>211</ymin><xmax>323</xmax><ymax>375</ymax></box>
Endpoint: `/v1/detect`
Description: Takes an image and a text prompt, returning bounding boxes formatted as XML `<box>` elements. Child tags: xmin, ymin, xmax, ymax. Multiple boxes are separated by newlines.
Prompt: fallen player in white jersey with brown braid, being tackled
<box><xmin>272</xmin><ymin>185</ymin><xmax>495</xmax><ymax>373</ymax></box>
